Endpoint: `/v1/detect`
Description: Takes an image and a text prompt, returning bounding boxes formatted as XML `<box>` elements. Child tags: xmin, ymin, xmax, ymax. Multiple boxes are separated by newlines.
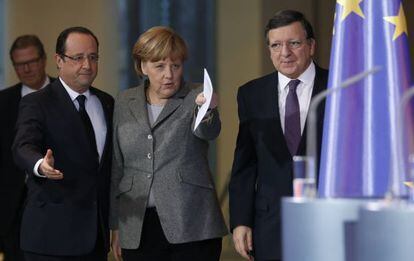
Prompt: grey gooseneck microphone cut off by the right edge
<box><xmin>387</xmin><ymin>85</ymin><xmax>414</xmax><ymax>198</ymax></box>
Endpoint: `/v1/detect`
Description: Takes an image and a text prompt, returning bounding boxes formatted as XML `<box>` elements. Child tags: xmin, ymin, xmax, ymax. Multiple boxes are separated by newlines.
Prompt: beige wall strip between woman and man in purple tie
<box><xmin>216</xmin><ymin>0</ymin><xmax>262</xmax><ymax>255</ymax></box>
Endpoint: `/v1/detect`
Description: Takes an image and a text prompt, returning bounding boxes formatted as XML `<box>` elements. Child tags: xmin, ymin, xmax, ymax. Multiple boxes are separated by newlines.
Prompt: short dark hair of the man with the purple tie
<box><xmin>265</xmin><ymin>10</ymin><xmax>314</xmax><ymax>44</ymax></box>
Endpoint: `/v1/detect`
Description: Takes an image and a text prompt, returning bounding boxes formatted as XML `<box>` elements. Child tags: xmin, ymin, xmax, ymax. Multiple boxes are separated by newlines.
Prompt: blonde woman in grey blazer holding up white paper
<box><xmin>110</xmin><ymin>27</ymin><xmax>227</xmax><ymax>261</ymax></box>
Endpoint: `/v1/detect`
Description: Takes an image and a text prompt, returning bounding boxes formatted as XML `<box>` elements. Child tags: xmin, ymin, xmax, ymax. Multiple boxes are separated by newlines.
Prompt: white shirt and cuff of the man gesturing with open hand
<box><xmin>34</xmin><ymin>78</ymin><xmax>107</xmax><ymax>177</ymax></box>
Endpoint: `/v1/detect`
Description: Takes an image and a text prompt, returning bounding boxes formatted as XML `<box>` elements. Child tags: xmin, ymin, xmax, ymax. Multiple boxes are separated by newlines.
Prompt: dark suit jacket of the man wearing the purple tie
<box><xmin>229</xmin><ymin>66</ymin><xmax>328</xmax><ymax>259</ymax></box>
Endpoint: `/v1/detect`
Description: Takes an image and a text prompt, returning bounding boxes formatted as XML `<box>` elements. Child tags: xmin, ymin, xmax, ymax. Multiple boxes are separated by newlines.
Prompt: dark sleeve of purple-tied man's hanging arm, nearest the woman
<box><xmin>229</xmin><ymin>88</ymin><xmax>257</xmax><ymax>230</ymax></box>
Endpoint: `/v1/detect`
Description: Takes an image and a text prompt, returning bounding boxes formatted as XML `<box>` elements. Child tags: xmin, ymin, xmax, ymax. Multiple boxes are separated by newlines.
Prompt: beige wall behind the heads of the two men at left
<box><xmin>4</xmin><ymin>0</ymin><xmax>119</xmax><ymax>95</ymax></box>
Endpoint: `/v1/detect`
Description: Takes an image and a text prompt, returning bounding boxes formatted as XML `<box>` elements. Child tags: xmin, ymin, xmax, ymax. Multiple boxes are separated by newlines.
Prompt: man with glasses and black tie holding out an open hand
<box><xmin>13</xmin><ymin>27</ymin><xmax>113</xmax><ymax>261</ymax></box>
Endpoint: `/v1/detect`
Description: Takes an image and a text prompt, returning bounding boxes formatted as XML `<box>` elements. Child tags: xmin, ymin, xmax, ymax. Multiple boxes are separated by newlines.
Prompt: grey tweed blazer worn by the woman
<box><xmin>110</xmin><ymin>80</ymin><xmax>228</xmax><ymax>249</ymax></box>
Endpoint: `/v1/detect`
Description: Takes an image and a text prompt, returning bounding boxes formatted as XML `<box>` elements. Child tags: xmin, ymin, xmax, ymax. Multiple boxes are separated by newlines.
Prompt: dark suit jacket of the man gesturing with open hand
<box><xmin>13</xmin><ymin>80</ymin><xmax>113</xmax><ymax>256</ymax></box>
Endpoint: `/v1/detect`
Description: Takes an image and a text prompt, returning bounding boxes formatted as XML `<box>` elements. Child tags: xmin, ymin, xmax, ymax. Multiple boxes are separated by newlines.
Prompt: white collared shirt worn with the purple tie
<box><xmin>277</xmin><ymin>62</ymin><xmax>316</xmax><ymax>133</ymax></box>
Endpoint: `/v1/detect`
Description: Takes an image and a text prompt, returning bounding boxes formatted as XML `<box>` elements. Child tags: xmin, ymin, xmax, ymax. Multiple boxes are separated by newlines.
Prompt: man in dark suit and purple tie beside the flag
<box><xmin>229</xmin><ymin>10</ymin><xmax>328</xmax><ymax>261</ymax></box>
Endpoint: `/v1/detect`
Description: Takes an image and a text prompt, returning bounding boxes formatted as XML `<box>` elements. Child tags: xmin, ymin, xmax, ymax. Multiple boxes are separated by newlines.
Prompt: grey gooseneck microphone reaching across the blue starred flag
<box><xmin>306</xmin><ymin>66</ymin><xmax>381</xmax><ymax>194</ymax></box>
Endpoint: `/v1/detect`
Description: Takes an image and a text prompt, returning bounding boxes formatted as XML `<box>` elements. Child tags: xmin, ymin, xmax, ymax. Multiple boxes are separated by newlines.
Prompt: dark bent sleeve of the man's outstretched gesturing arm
<box><xmin>12</xmin><ymin>95</ymin><xmax>46</xmax><ymax>174</ymax></box>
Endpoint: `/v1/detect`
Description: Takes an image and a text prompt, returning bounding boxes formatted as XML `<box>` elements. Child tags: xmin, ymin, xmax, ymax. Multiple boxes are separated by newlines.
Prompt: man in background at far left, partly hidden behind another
<box><xmin>0</xmin><ymin>35</ymin><xmax>54</xmax><ymax>261</ymax></box>
